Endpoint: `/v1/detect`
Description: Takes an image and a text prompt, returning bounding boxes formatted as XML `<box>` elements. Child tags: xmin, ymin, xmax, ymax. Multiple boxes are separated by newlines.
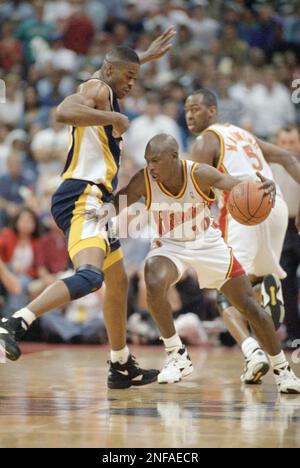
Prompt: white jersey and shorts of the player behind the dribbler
<box><xmin>200</xmin><ymin>124</ymin><xmax>287</xmax><ymax>278</ymax></box>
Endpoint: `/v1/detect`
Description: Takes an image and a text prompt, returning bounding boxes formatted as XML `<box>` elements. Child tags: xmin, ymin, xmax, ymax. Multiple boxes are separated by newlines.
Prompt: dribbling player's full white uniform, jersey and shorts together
<box><xmin>144</xmin><ymin>160</ymin><xmax>244</xmax><ymax>289</ymax></box>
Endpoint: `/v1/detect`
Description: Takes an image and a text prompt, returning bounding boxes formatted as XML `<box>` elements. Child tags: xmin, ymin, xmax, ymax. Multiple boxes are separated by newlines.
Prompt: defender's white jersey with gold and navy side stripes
<box><xmin>62</xmin><ymin>78</ymin><xmax>122</xmax><ymax>193</ymax></box>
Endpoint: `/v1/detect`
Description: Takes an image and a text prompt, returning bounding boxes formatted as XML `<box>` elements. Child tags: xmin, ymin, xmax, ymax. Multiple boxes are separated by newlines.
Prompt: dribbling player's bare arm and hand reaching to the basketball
<box><xmin>194</xmin><ymin>164</ymin><xmax>276</xmax><ymax>204</ymax></box>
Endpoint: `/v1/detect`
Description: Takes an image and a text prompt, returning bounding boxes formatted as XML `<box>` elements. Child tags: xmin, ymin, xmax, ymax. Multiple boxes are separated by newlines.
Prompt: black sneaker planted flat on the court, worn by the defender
<box><xmin>107</xmin><ymin>354</ymin><xmax>159</xmax><ymax>388</ymax></box>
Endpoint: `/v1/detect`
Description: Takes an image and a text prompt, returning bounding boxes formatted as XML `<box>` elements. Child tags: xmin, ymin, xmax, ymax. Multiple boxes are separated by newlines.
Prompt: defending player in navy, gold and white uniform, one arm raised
<box><xmin>0</xmin><ymin>28</ymin><xmax>175</xmax><ymax>388</ymax></box>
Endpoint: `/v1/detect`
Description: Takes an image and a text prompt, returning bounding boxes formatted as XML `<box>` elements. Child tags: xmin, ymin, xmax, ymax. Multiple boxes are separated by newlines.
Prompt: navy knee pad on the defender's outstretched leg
<box><xmin>63</xmin><ymin>265</ymin><xmax>104</xmax><ymax>300</ymax></box>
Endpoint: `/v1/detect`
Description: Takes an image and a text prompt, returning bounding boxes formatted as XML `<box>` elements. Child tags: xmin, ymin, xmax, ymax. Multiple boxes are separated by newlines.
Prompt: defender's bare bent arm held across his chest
<box><xmin>56</xmin><ymin>80</ymin><xmax>129</xmax><ymax>136</ymax></box>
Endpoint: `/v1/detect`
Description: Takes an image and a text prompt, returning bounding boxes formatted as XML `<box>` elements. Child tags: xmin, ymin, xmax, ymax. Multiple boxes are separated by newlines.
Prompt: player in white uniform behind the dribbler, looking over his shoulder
<box><xmin>185</xmin><ymin>89</ymin><xmax>300</xmax><ymax>383</ymax></box>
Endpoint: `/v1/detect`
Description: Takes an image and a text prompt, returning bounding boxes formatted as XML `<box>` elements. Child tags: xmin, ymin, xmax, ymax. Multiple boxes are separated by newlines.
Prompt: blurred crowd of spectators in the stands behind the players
<box><xmin>0</xmin><ymin>0</ymin><xmax>300</xmax><ymax>343</ymax></box>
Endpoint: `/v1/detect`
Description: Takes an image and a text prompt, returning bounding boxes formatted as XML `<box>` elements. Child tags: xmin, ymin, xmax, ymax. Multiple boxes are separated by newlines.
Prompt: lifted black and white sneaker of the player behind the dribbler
<box><xmin>261</xmin><ymin>275</ymin><xmax>285</xmax><ymax>330</ymax></box>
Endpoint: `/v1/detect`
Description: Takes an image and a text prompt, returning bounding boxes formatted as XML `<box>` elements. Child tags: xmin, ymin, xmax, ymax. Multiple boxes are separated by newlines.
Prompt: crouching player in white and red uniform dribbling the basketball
<box><xmin>86</xmin><ymin>134</ymin><xmax>300</xmax><ymax>393</ymax></box>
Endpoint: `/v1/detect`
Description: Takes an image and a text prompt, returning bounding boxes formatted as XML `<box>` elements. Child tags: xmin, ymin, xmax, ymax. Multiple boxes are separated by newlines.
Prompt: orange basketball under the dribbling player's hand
<box><xmin>228</xmin><ymin>180</ymin><xmax>272</xmax><ymax>226</ymax></box>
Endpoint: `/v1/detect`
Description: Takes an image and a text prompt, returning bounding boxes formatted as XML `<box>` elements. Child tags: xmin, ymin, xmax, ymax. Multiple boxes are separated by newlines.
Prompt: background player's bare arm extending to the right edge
<box><xmin>257</xmin><ymin>138</ymin><xmax>300</xmax><ymax>184</ymax></box>
